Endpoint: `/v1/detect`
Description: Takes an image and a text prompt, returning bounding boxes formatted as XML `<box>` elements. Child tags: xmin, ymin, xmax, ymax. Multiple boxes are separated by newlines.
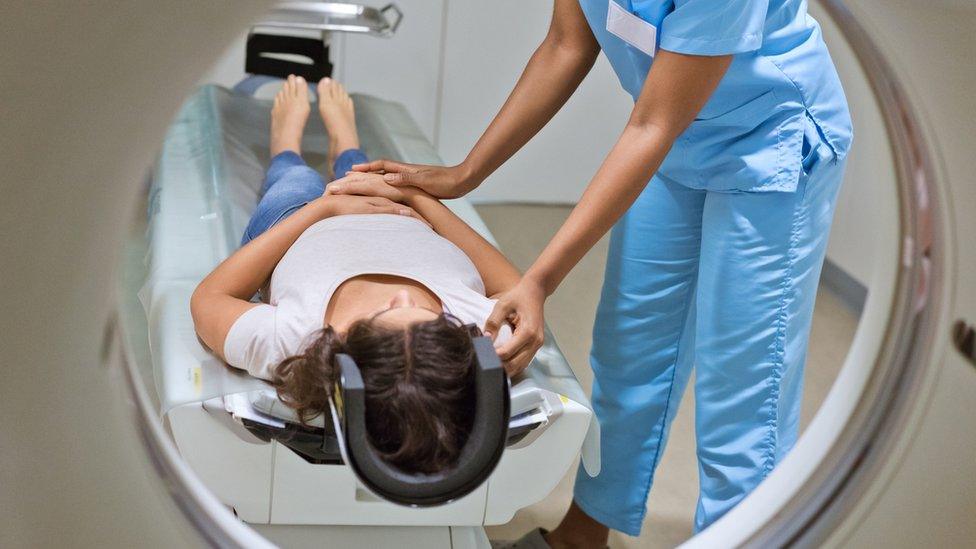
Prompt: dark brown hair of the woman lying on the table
<box><xmin>272</xmin><ymin>315</ymin><xmax>480</xmax><ymax>474</ymax></box>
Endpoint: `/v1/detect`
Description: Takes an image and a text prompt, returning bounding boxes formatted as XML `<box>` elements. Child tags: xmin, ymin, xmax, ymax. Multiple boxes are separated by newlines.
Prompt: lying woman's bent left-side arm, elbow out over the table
<box><xmin>190</xmin><ymin>196</ymin><xmax>419</xmax><ymax>358</ymax></box>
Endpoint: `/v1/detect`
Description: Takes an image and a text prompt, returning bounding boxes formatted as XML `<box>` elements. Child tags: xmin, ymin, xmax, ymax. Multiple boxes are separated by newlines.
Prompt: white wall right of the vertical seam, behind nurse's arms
<box><xmin>438</xmin><ymin>0</ymin><xmax>633</xmax><ymax>203</ymax></box>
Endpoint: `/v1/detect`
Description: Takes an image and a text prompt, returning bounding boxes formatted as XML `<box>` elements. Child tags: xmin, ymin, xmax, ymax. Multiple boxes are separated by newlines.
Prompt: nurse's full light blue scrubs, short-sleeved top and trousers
<box><xmin>575</xmin><ymin>0</ymin><xmax>851</xmax><ymax>535</ymax></box>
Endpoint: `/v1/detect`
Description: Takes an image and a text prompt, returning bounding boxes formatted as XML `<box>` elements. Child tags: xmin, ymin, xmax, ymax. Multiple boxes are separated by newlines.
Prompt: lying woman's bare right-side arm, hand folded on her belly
<box><xmin>325</xmin><ymin>173</ymin><xmax>521</xmax><ymax>297</ymax></box>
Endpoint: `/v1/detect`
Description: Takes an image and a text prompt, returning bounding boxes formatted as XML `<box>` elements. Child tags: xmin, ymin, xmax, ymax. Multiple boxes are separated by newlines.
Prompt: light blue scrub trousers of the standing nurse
<box><xmin>575</xmin><ymin>131</ymin><xmax>844</xmax><ymax>535</ymax></box>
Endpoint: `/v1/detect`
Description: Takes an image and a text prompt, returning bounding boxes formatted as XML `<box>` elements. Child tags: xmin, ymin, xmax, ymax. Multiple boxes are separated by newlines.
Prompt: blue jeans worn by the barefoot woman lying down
<box><xmin>241</xmin><ymin>149</ymin><xmax>368</xmax><ymax>246</ymax></box>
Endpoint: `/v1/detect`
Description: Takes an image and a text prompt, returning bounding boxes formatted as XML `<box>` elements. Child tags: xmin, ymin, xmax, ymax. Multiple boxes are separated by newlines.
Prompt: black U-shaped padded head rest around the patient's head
<box><xmin>333</xmin><ymin>336</ymin><xmax>509</xmax><ymax>506</ymax></box>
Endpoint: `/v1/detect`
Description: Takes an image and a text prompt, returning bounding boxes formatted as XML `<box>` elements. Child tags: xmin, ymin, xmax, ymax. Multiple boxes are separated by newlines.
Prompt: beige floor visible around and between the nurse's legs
<box><xmin>477</xmin><ymin>204</ymin><xmax>857</xmax><ymax>549</ymax></box>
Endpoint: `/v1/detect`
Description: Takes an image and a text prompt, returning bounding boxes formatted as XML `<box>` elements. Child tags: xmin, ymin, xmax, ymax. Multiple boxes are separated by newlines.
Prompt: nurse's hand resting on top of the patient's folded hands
<box><xmin>352</xmin><ymin>160</ymin><xmax>480</xmax><ymax>198</ymax></box>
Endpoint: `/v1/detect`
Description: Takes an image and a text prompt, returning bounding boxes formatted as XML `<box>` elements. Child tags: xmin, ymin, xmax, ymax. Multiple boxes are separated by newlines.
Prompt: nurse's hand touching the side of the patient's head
<box><xmin>485</xmin><ymin>277</ymin><xmax>546</xmax><ymax>377</ymax></box>
